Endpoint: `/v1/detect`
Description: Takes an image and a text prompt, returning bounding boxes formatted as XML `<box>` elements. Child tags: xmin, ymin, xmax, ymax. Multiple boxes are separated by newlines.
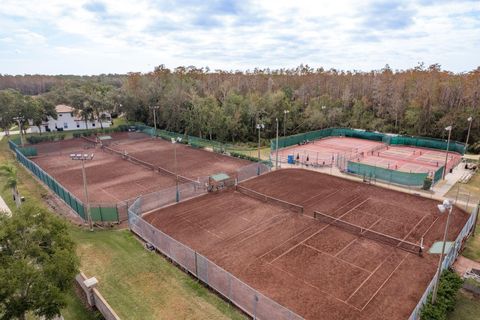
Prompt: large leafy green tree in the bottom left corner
<box><xmin>0</xmin><ymin>205</ymin><xmax>78</xmax><ymax>319</ymax></box>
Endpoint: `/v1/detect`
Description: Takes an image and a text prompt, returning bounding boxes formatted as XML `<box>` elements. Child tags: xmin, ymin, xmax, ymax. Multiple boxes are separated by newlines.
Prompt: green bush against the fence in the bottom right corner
<box><xmin>420</xmin><ymin>270</ymin><xmax>463</xmax><ymax>320</ymax></box>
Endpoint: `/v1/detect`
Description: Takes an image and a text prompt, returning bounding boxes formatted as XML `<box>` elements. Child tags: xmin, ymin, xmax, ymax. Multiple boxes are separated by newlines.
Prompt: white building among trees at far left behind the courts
<box><xmin>29</xmin><ymin>104</ymin><xmax>111</xmax><ymax>133</ymax></box>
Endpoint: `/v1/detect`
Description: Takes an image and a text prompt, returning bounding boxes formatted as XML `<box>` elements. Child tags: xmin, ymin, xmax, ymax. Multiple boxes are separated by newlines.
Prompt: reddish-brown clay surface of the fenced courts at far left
<box><xmin>31</xmin><ymin>132</ymin><xmax>250</xmax><ymax>204</ymax></box>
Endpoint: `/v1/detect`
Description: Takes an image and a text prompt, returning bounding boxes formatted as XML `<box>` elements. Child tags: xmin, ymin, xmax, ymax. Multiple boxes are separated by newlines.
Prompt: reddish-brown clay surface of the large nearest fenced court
<box><xmin>144</xmin><ymin>169</ymin><xmax>468</xmax><ymax>320</ymax></box>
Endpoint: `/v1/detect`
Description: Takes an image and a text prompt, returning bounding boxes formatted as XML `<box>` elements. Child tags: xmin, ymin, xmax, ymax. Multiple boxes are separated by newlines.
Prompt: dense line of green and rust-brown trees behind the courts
<box><xmin>0</xmin><ymin>64</ymin><xmax>480</xmax><ymax>151</ymax></box>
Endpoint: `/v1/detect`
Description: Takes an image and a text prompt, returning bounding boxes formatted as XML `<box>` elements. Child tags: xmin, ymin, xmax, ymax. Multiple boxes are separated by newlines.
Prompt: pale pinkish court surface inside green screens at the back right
<box><xmin>272</xmin><ymin>137</ymin><xmax>461</xmax><ymax>173</ymax></box>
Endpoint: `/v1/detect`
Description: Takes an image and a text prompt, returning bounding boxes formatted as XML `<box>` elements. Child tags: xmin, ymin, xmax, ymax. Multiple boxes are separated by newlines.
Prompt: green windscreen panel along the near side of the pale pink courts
<box><xmin>347</xmin><ymin>161</ymin><xmax>428</xmax><ymax>186</ymax></box>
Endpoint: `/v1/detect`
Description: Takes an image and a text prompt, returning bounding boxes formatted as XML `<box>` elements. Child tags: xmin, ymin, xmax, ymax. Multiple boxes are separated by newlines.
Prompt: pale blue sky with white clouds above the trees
<box><xmin>0</xmin><ymin>0</ymin><xmax>480</xmax><ymax>74</ymax></box>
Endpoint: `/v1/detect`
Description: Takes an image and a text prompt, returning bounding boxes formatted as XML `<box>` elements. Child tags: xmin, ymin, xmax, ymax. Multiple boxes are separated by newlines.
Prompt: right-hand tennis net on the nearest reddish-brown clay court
<box><xmin>313</xmin><ymin>211</ymin><xmax>423</xmax><ymax>255</ymax></box>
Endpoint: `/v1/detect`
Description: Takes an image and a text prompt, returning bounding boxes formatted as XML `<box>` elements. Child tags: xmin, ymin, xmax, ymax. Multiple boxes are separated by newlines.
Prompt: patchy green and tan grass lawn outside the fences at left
<box><xmin>0</xmin><ymin>139</ymin><xmax>246</xmax><ymax>320</ymax></box>
